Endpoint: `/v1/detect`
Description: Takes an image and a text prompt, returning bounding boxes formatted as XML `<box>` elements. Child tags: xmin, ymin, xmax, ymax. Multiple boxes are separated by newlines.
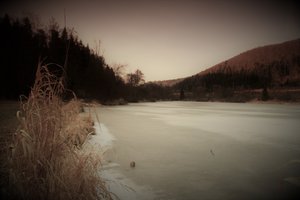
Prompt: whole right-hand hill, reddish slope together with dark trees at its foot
<box><xmin>174</xmin><ymin>39</ymin><xmax>300</xmax><ymax>101</ymax></box>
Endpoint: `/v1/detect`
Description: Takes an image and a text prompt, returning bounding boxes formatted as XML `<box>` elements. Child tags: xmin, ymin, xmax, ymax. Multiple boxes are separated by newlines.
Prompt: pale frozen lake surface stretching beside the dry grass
<box><xmin>92</xmin><ymin>102</ymin><xmax>300</xmax><ymax>200</ymax></box>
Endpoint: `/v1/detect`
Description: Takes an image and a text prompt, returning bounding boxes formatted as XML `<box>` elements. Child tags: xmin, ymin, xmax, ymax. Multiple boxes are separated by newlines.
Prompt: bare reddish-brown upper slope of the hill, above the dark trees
<box><xmin>156</xmin><ymin>38</ymin><xmax>300</xmax><ymax>86</ymax></box>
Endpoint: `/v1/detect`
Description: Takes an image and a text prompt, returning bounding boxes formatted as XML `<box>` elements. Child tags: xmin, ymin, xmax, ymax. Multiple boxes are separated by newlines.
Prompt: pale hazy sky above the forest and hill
<box><xmin>0</xmin><ymin>0</ymin><xmax>300</xmax><ymax>81</ymax></box>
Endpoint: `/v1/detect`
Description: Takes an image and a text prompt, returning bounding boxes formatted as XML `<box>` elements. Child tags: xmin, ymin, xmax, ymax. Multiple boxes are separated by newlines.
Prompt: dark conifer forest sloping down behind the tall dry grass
<box><xmin>0</xmin><ymin>15</ymin><xmax>172</xmax><ymax>102</ymax></box>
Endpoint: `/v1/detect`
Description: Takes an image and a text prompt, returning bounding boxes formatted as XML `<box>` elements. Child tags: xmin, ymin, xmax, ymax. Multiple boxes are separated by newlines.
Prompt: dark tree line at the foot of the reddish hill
<box><xmin>174</xmin><ymin>55</ymin><xmax>300</xmax><ymax>101</ymax></box>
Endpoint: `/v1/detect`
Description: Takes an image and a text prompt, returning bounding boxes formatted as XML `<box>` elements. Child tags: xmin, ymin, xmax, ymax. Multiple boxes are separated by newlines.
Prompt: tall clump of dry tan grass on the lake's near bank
<box><xmin>8</xmin><ymin>64</ymin><xmax>111</xmax><ymax>200</ymax></box>
